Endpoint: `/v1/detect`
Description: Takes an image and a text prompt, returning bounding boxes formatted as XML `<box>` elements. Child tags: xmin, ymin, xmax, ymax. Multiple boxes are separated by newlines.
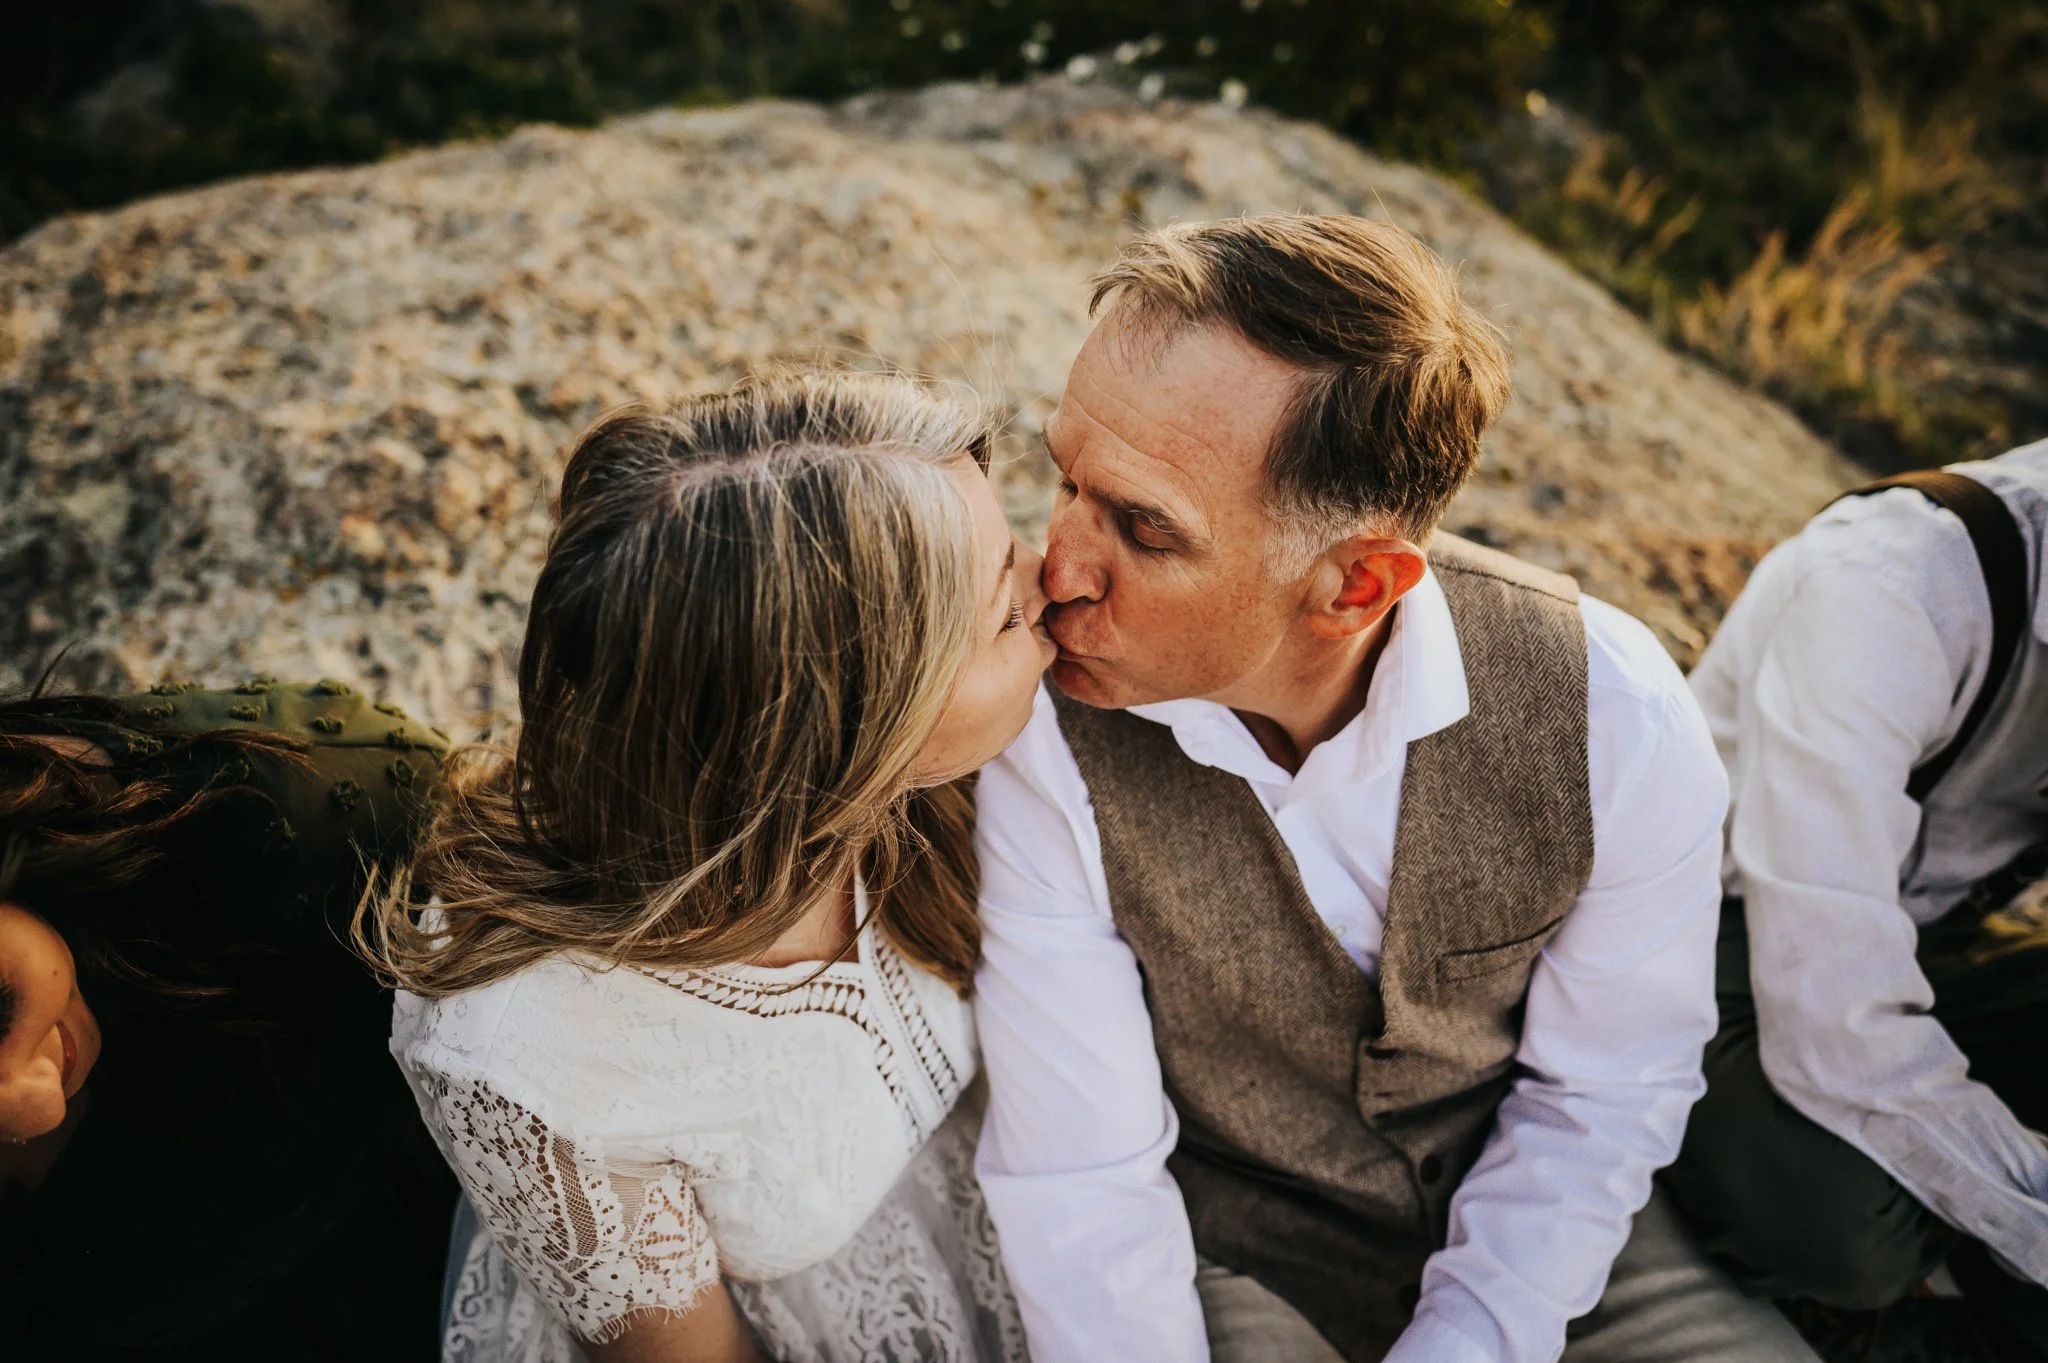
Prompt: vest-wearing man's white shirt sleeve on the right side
<box><xmin>1386</xmin><ymin>600</ymin><xmax>1729</xmax><ymax>1363</ymax></box>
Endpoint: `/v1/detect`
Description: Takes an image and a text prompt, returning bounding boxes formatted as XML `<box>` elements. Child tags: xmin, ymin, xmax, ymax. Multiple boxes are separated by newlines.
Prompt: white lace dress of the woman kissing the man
<box><xmin>391</xmin><ymin>892</ymin><xmax>1026</xmax><ymax>1363</ymax></box>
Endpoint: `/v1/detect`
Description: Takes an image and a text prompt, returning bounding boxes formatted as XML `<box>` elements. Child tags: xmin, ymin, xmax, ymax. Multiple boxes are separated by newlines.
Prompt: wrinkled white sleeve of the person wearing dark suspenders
<box><xmin>1702</xmin><ymin>497</ymin><xmax>2048</xmax><ymax>1283</ymax></box>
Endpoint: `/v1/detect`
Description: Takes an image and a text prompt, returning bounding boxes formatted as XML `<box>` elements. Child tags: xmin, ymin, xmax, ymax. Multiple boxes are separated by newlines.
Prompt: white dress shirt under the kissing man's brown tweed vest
<box><xmin>975</xmin><ymin>575</ymin><xmax>1726</xmax><ymax>1363</ymax></box>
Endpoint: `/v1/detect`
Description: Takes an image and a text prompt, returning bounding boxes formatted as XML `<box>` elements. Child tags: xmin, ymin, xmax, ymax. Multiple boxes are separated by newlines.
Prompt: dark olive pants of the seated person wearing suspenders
<box><xmin>1661</xmin><ymin>900</ymin><xmax>2048</xmax><ymax>1340</ymax></box>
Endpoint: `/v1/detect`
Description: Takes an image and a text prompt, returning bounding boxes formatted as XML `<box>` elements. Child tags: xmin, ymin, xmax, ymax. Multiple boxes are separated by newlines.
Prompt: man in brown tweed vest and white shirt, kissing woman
<box><xmin>977</xmin><ymin>217</ymin><xmax>1812</xmax><ymax>1363</ymax></box>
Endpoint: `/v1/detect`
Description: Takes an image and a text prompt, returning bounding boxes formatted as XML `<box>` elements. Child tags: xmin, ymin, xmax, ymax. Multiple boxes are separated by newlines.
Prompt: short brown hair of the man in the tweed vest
<box><xmin>1090</xmin><ymin>213</ymin><xmax>1509</xmax><ymax>548</ymax></box>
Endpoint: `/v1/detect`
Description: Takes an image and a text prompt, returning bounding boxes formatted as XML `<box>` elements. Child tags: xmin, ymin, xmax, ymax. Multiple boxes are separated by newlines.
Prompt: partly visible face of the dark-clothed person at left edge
<box><xmin>0</xmin><ymin>903</ymin><xmax>100</xmax><ymax>1142</ymax></box>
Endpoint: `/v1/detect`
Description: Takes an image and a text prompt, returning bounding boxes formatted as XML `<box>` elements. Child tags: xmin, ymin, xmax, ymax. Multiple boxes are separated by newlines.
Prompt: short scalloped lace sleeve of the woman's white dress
<box><xmin>422</xmin><ymin>1074</ymin><xmax>719</xmax><ymax>1340</ymax></box>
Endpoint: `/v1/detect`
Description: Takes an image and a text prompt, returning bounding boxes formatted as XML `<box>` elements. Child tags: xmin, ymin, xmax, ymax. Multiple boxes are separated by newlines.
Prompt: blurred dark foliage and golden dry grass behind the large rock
<box><xmin>0</xmin><ymin>0</ymin><xmax>2048</xmax><ymax>463</ymax></box>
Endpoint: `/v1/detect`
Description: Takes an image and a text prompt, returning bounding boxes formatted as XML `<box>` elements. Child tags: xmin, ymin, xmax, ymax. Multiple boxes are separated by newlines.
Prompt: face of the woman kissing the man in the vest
<box><xmin>915</xmin><ymin>458</ymin><xmax>1059</xmax><ymax>784</ymax></box>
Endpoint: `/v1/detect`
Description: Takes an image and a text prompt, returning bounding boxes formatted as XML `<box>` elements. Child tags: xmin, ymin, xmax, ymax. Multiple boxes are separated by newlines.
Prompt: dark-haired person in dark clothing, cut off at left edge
<box><xmin>0</xmin><ymin>677</ymin><xmax>455</xmax><ymax>1363</ymax></box>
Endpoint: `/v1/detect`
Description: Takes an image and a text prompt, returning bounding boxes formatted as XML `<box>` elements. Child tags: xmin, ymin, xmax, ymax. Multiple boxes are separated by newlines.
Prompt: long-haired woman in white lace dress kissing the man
<box><xmin>381</xmin><ymin>375</ymin><xmax>1053</xmax><ymax>1363</ymax></box>
